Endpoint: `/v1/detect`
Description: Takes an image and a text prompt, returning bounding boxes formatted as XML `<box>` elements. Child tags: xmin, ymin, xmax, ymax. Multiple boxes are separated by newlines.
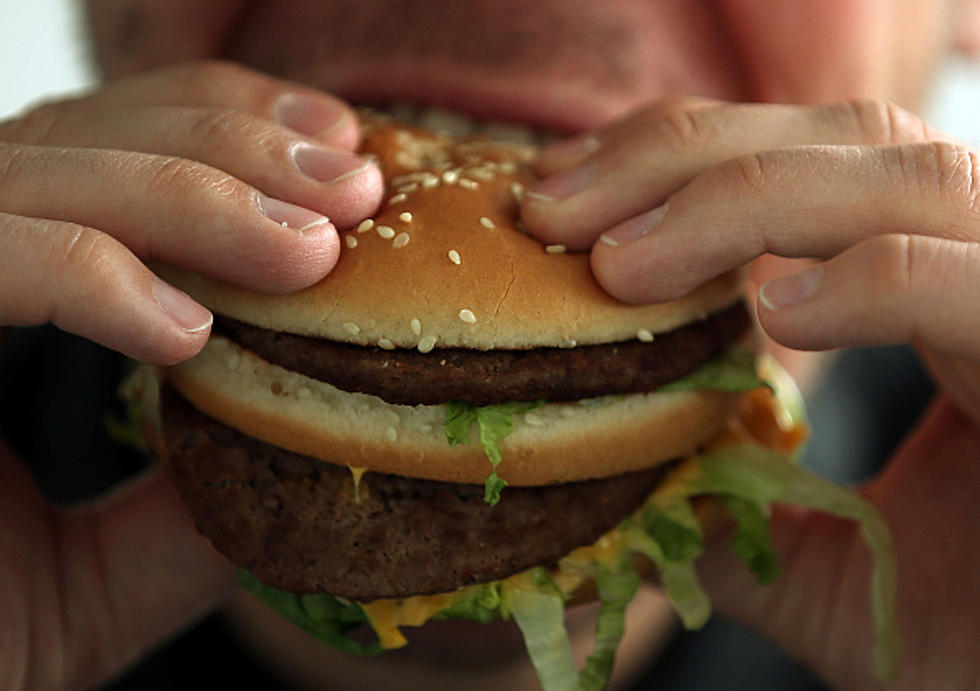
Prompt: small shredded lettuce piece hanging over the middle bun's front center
<box><xmin>443</xmin><ymin>401</ymin><xmax>544</xmax><ymax>506</ymax></box>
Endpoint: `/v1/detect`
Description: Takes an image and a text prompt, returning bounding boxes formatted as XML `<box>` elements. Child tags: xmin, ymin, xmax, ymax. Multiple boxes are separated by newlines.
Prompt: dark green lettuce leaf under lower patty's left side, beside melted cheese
<box><xmin>238</xmin><ymin>569</ymin><xmax>381</xmax><ymax>656</ymax></box>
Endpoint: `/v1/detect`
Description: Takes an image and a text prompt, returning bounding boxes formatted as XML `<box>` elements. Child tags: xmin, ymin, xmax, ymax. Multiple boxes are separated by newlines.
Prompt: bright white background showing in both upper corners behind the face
<box><xmin>0</xmin><ymin>0</ymin><xmax>980</xmax><ymax>145</ymax></box>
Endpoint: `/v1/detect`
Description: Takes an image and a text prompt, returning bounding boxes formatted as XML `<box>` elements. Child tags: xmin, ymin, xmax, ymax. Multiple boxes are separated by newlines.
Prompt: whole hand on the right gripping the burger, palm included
<box><xmin>521</xmin><ymin>100</ymin><xmax>980</xmax><ymax>689</ymax></box>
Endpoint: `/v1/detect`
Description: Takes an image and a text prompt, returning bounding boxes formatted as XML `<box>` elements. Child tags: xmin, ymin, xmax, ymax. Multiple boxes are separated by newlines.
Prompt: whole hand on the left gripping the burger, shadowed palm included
<box><xmin>0</xmin><ymin>63</ymin><xmax>382</xmax><ymax>689</ymax></box>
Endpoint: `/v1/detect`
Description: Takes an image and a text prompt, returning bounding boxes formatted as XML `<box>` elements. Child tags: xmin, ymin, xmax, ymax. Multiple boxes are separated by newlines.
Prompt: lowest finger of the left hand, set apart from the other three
<box><xmin>0</xmin><ymin>213</ymin><xmax>212</xmax><ymax>365</ymax></box>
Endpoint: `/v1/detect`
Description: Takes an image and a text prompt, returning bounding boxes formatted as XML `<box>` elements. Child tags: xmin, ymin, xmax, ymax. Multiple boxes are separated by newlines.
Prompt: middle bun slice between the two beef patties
<box><xmin>168</xmin><ymin>337</ymin><xmax>739</xmax><ymax>486</ymax></box>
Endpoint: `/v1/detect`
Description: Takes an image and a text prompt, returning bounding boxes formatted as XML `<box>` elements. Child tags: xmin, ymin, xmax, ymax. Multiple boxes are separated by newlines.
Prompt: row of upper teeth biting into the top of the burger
<box><xmin>372</xmin><ymin>103</ymin><xmax>561</xmax><ymax>146</ymax></box>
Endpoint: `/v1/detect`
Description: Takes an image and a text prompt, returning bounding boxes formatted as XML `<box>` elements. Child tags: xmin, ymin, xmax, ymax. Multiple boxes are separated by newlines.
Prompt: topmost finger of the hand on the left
<box><xmin>32</xmin><ymin>60</ymin><xmax>360</xmax><ymax>151</ymax></box>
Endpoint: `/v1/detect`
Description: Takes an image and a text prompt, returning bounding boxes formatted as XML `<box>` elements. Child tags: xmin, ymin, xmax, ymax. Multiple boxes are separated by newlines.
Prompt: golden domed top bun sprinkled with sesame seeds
<box><xmin>161</xmin><ymin>116</ymin><xmax>741</xmax><ymax>351</ymax></box>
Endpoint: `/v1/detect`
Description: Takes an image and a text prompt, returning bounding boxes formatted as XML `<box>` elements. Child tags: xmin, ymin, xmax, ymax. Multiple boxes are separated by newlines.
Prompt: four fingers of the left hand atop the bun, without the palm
<box><xmin>0</xmin><ymin>62</ymin><xmax>383</xmax><ymax>364</ymax></box>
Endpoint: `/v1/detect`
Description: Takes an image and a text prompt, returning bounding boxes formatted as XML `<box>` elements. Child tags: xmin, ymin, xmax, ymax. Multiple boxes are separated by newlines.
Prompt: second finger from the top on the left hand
<box><xmin>0</xmin><ymin>106</ymin><xmax>383</xmax><ymax>227</ymax></box>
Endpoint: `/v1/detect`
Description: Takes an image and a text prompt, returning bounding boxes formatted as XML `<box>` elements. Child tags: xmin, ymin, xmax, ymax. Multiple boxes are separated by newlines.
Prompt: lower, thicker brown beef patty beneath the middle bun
<box><xmin>161</xmin><ymin>387</ymin><xmax>664</xmax><ymax>601</ymax></box>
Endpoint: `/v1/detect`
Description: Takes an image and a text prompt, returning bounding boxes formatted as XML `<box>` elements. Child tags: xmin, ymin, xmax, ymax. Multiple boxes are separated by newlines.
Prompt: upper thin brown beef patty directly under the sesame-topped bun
<box><xmin>214</xmin><ymin>302</ymin><xmax>749</xmax><ymax>405</ymax></box>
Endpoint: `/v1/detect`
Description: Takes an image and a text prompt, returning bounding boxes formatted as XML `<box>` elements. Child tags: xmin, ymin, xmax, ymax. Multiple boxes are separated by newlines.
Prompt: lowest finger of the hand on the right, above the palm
<box><xmin>759</xmin><ymin>235</ymin><xmax>980</xmax><ymax>354</ymax></box>
